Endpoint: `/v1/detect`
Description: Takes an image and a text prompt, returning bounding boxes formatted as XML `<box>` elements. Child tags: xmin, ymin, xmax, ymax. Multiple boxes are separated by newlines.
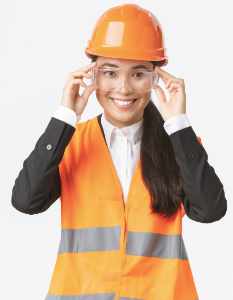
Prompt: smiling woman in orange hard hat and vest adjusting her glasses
<box><xmin>12</xmin><ymin>4</ymin><xmax>227</xmax><ymax>300</ymax></box>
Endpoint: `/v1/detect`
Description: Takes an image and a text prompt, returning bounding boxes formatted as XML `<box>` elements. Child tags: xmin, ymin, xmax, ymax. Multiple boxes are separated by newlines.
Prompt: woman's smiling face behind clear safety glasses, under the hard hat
<box><xmin>93</xmin><ymin>56</ymin><xmax>153</xmax><ymax>127</ymax></box>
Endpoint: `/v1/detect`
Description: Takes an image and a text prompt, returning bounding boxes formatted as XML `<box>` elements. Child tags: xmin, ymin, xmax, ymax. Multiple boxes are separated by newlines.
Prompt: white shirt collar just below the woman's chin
<box><xmin>101</xmin><ymin>112</ymin><xmax>143</xmax><ymax>147</ymax></box>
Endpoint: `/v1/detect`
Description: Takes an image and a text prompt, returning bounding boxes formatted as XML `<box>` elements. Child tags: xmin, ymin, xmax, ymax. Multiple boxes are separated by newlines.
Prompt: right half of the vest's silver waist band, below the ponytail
<box><xmin>126</xmin><ymin>231</ymin><xmax>188</xmax><ymax>259</ymax></box>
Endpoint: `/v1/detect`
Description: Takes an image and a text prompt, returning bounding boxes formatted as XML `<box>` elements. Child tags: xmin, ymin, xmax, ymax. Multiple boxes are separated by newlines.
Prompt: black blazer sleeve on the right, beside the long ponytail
<box><xmin>169</xmin><ymin>126</ymin><xmax>227</xmax><ymax>223</ymax></box>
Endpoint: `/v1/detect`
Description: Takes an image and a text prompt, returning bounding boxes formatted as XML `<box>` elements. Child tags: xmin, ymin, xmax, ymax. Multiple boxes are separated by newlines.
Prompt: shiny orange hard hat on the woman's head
<box><xmin>85</xmin><ymin>4</ymin><xmax>168</xmax><ymax>65</ymax></box>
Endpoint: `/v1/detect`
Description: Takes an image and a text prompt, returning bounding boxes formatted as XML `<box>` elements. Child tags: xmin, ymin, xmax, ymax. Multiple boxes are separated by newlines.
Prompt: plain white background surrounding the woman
<box><xmin>0</xmin><ymin>0</ymin><xmax>233</xmax><ymax>300</ymax></box>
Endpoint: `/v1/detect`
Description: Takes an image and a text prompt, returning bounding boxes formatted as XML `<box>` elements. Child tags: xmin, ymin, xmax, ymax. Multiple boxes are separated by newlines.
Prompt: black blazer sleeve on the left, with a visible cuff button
<box><xmin>11</xmin><ymin>117</ymin><xmax>76</xmax><ymax>215</ymax></box>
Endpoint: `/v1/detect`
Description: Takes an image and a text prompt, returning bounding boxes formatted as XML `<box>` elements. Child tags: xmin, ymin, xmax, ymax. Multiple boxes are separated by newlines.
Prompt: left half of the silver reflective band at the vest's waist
<box><xmin>58</xmin><ymin>226</ymin><xmax>120</xmax><ymax>253</ymax></box>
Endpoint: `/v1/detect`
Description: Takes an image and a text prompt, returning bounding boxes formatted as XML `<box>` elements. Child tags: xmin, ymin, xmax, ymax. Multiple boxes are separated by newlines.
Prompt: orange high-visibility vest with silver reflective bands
<box><xmin>46</xmin><ymin>116</ymin><xmax>198</xmax><ymax>300</ymax></box>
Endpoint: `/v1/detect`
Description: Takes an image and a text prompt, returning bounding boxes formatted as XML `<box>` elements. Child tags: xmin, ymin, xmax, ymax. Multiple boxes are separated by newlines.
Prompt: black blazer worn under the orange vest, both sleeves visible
<box><xmin>11</xmin><ymin>114</ymin><xmax>227</xmax><ymax>223</ymax></box>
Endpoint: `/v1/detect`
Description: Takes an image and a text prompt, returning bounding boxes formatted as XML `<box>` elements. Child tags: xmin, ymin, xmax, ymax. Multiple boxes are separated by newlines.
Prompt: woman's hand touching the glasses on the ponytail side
<box><xmin>153</xmin><ymin>66</ymin><xmax>186</xmax><ymax>121</ymax></box>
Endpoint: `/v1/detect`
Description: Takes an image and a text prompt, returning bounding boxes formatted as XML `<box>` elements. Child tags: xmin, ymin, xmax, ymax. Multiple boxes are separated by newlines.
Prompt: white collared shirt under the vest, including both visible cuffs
<box><xmin>52</xmin><ymin>105</ymin><xmax>190</xmax><ymax>201</ymax></box>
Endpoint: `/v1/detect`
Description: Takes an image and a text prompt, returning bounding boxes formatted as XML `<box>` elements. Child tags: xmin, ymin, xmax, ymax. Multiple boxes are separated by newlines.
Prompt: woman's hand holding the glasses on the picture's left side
<box><xmin>61</xmin><ymin>62</ymin><xmax>96</xmax><ymax>115</ymax></box>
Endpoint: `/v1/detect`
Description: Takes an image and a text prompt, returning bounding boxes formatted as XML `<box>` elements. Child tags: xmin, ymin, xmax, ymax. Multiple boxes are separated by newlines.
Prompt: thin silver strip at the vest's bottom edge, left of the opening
<box><xmin>45</xmin><ymin>293</ymin><xmax>115</xmax><ymax>300</ymax></box>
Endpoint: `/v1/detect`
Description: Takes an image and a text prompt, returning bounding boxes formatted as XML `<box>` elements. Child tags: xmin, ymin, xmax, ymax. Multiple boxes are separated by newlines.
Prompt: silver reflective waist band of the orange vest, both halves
<box><xmin>58</xmin><ymin>226</ymin><xmax>188</xmax><ymax>259</ymax></box>
